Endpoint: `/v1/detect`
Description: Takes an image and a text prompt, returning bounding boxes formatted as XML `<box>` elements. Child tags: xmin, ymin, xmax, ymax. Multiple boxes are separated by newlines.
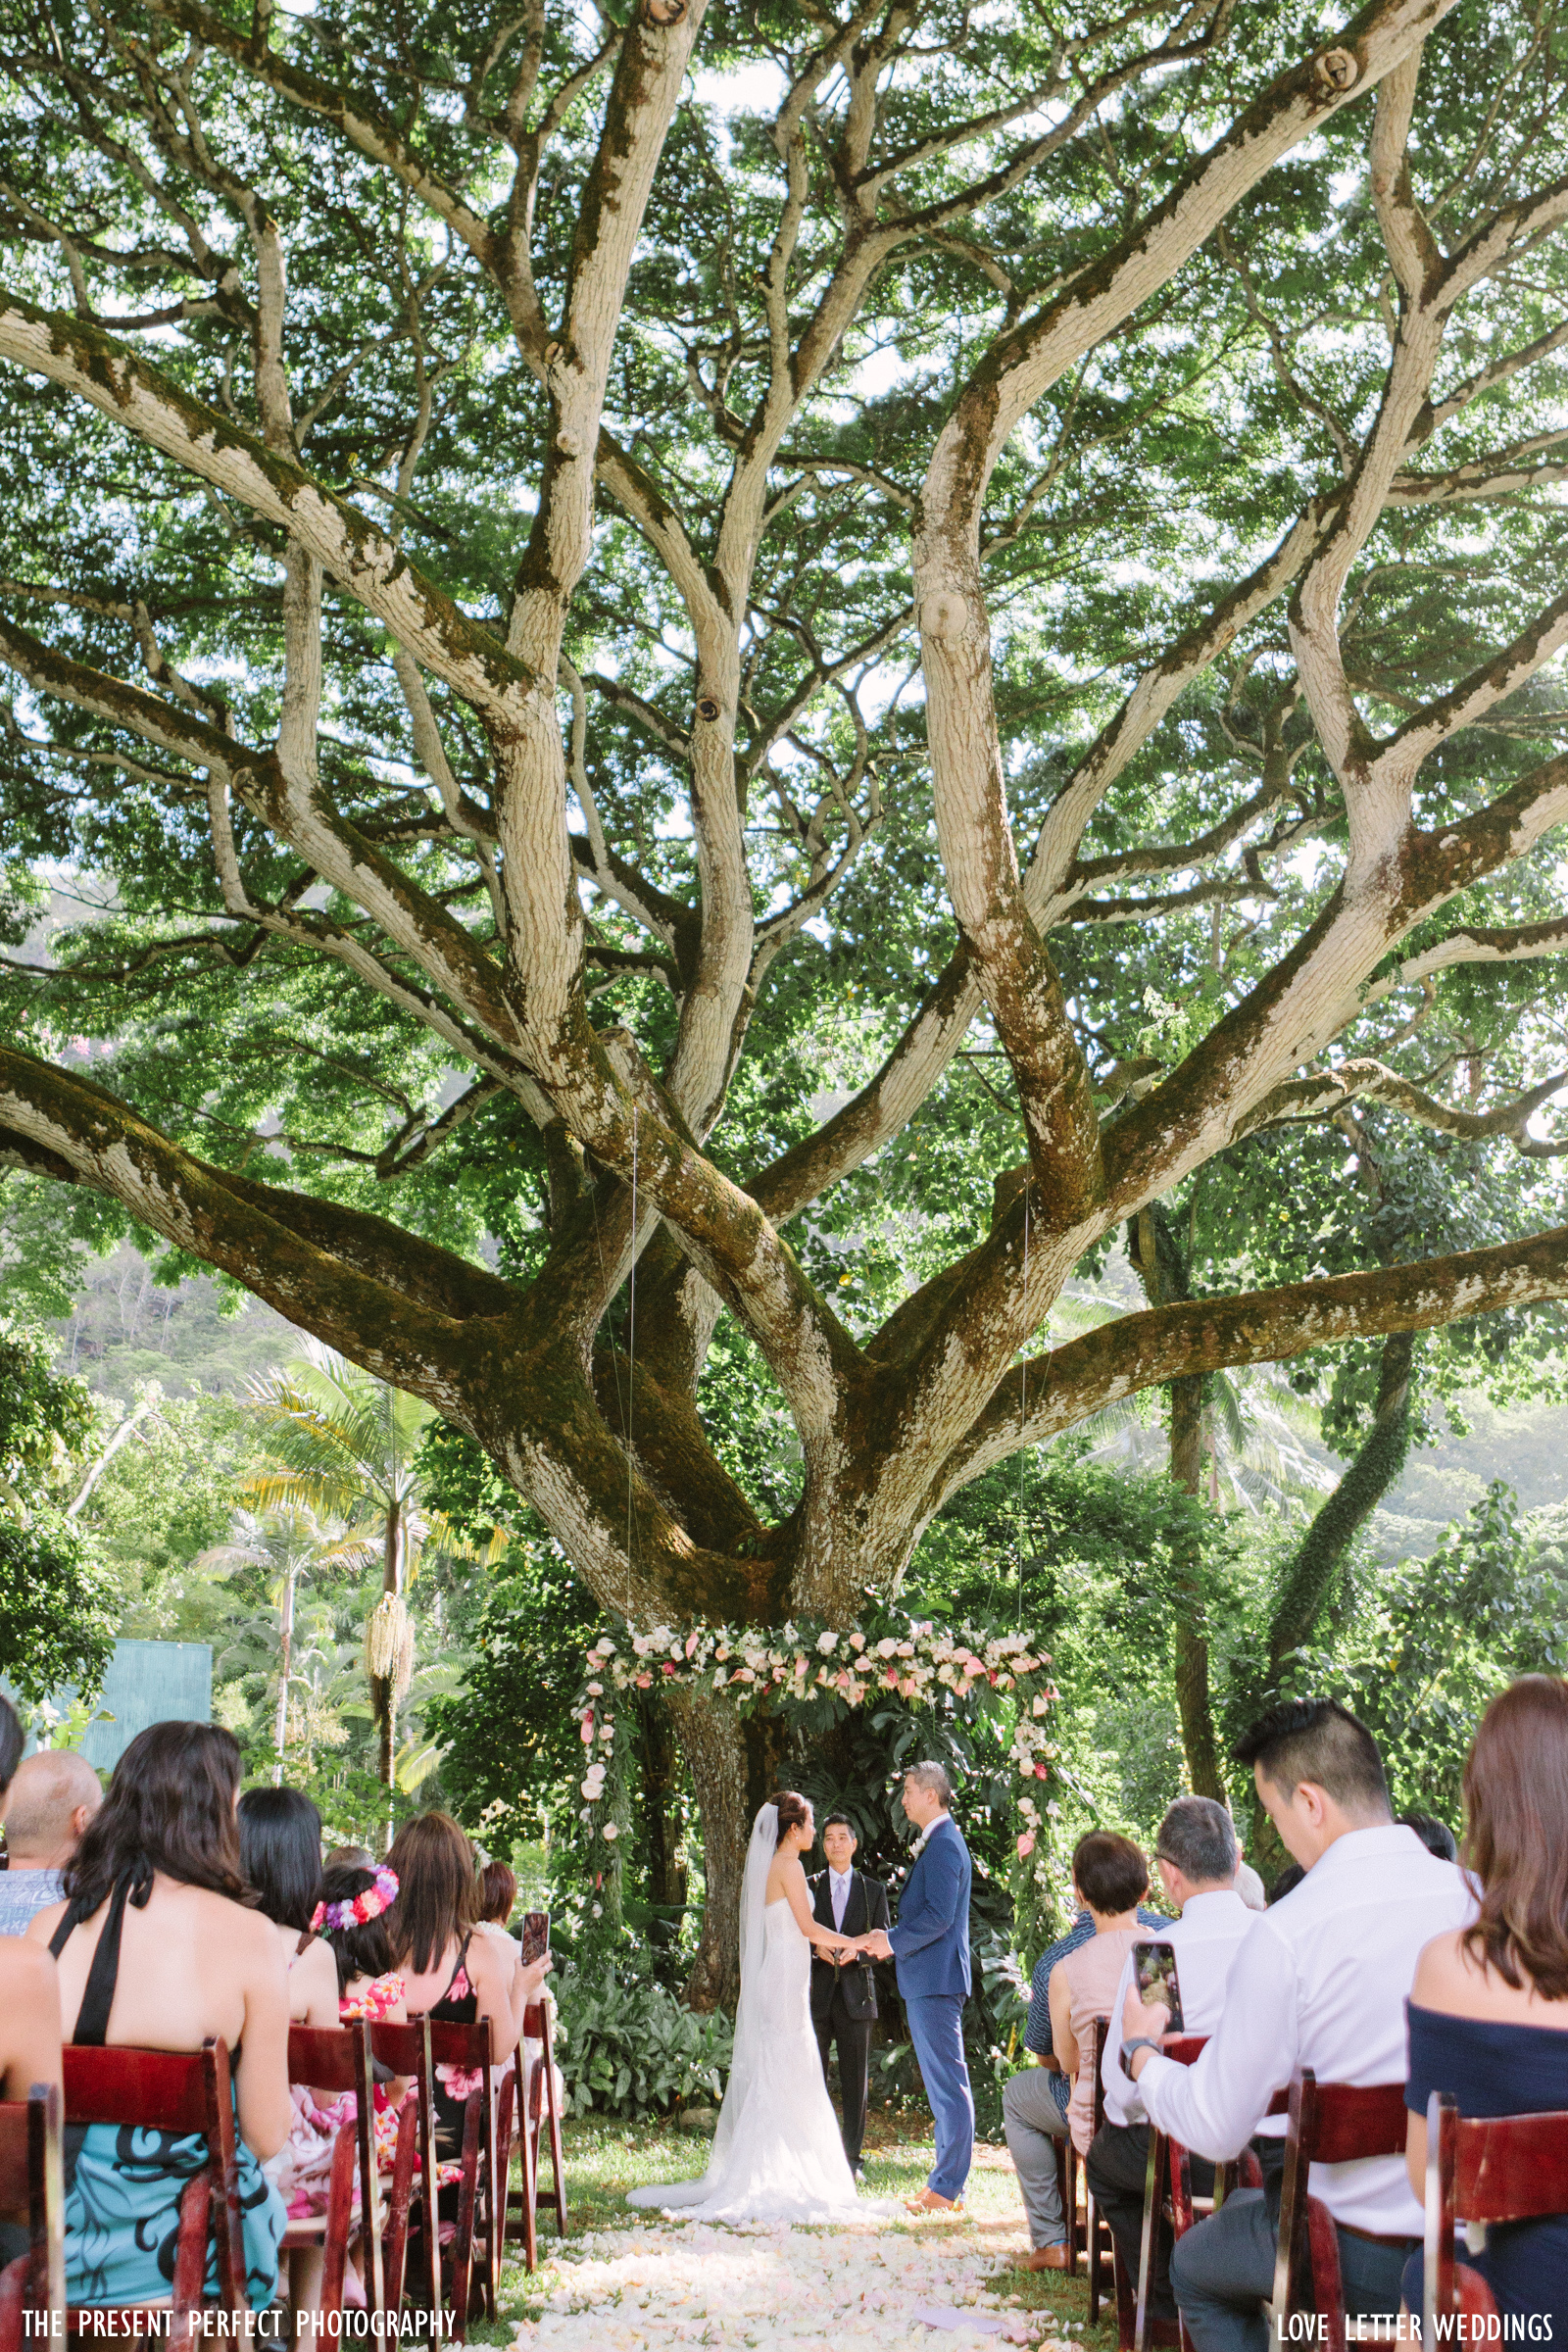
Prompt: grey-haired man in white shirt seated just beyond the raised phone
<box><xmin>1086</xmin><ymin>1797</ymin><xmax>1253</xmax><ymax>2319</ymax></box>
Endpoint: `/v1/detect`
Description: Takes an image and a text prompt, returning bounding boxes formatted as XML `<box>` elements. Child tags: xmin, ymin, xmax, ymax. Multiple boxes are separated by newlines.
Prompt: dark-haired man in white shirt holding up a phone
<box><xmin>1121</xmin><ymin>1698</ymin><xmax>1474</xmax><ymax>2352</ymax></box>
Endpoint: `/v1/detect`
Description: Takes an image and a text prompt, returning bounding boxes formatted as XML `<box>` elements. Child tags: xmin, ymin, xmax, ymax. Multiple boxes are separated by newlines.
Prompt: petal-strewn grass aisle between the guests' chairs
<box><xmin>484</xmin><ymin>2117</ymin><xmax>1114</xmax><ymax>2352</ymax></box>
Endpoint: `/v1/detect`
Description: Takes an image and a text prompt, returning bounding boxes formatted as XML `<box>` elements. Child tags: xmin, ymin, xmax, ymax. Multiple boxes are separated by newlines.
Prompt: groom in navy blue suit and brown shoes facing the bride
<box><xmin>860</xmin><ymin>1764</ymin><xmax>976</xmax><ymax>2213</ymax></box>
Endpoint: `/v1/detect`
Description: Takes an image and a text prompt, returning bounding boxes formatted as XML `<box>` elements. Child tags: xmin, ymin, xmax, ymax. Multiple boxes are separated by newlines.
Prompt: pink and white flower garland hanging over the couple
<box><xmin>576</xmin><ymin>1609</ymin><xmax>1060</xmax><ymax>1940</ymax></box>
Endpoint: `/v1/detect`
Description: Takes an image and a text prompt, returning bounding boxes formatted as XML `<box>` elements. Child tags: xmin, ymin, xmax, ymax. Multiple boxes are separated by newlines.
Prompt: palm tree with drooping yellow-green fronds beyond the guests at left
<box><xmin>244</xmin><ymin>1339</ymin><xmax>506</xmax><ymax>1833</ymax></box>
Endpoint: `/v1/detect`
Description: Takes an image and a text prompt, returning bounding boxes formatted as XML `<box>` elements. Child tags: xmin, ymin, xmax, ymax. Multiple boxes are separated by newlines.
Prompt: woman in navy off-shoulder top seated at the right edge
<box><xmin>1403</xmin><ymin>1675</ymin><xmax>1568</xmax><ymax>2342</ymax></box>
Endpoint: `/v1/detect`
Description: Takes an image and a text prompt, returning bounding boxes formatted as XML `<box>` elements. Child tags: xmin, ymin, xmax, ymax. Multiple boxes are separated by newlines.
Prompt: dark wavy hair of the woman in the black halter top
<box><xmin>66</xmin><ymin>1724</ymin><xmax>256</xmax><ymax>1919</ymax></box>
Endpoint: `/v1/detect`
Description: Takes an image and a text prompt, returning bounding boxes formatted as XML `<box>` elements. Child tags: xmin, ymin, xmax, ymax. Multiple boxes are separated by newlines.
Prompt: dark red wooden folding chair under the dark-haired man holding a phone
<box><xmin>1274</xmin><ymin>2065</ymin><xmax>1405</xmax><ymax>2352</ymax></box>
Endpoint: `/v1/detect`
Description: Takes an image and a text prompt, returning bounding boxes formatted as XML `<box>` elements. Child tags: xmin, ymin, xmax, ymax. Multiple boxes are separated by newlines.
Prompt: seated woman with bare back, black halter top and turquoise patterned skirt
<box><xmin>28</xmin><ymin>1724</ymin><xmax>289</xmax><ymax>2307</ymax></box>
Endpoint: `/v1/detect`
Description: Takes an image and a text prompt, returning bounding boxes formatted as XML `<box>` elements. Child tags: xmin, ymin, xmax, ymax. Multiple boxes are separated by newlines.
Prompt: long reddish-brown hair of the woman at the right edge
<box><xmin>1462</xmin><ymin>1675</ymin><xmax>1568</xmax><ymax>2001</ymax></box>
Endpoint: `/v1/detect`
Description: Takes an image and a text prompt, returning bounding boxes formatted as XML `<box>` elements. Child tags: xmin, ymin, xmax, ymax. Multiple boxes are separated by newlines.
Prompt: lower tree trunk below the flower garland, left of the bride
<box><xmin>670</xmin><ymin>1691</ymin><xmax>788</xmax><ymax>2011</ymax></box>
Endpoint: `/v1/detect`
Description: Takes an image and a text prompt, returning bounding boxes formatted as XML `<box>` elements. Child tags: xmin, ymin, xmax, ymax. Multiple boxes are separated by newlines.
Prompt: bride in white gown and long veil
<box><xmin>625</xmin><ymin>1794</ymin><xmax>877</xmax><ymax>2223</ymax></box>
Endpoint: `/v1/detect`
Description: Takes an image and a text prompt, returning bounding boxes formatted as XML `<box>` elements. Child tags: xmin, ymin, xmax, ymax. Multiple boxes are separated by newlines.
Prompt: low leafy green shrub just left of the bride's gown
<box><xmin>555</xmin><ymin>1969</ymin><xmax>736</xmax><ymax>2115</ymax></box>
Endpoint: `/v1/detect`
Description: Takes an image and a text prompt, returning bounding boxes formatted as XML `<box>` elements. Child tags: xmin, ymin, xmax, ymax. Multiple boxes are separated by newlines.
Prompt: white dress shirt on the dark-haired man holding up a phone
<box><xmin>1138</xmin><ymin>1823</ymin><xmax>1476</xmax><ymax>2236</ymax></box>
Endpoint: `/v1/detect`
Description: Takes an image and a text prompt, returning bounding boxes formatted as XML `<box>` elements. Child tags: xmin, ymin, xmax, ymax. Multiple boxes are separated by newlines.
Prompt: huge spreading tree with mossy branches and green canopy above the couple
<box><xmin>0</xmin><ymin>0</ymin><xmax>1568</xmax><ymax>1999</ymax></box>
